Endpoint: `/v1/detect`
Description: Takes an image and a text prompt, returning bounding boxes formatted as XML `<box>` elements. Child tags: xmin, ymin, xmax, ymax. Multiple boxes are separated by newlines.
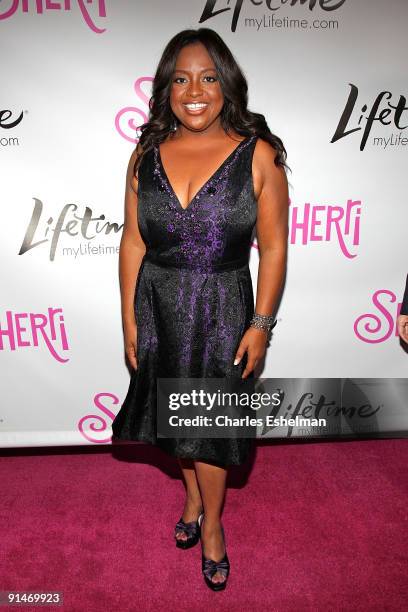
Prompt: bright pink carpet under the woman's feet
<box><xmin>0</xmin><ymin>440</ymin><xmax>408</xmax><ymax>612</ymax></box>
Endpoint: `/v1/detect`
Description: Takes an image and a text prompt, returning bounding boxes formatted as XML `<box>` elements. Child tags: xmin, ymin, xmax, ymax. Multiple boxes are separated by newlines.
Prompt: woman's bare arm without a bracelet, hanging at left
<box><xmin>119</xmin><ymin>143</ymin><xmax>146</xmax><ymax>369</ymax></box>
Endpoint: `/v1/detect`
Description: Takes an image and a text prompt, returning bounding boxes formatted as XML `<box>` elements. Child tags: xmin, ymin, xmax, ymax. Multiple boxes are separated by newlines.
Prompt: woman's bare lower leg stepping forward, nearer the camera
<box><xmin>194</xmin><ymin>461</ymin><xmax>227</xmax><ymax>582</ymax></box>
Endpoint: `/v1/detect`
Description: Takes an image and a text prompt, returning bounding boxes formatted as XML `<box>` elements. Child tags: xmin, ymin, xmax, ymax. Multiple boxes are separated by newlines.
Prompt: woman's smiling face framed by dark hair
<box><xmin>170</xmin><ymin>43</ymin><xmax>224</xmax><ymax>132</ymax></box>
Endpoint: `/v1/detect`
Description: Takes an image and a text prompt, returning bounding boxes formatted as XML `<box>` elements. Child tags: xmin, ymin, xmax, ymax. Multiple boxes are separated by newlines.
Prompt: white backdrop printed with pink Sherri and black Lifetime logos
<box><xmin>0</xmin><ymin>0</ymin><xmax>408</xmax><ymax>447</ymax></box>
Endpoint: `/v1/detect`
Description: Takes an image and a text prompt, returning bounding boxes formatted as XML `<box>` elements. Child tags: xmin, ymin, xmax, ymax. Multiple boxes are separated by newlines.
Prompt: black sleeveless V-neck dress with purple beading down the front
<box><xmin>112</xmin><ymin>136</ymin><xmax>257</xmax><ymax>466</ymax></box>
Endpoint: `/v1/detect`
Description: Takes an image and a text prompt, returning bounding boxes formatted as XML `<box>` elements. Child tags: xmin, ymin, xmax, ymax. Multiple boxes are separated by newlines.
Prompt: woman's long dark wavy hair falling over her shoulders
<box><xmin>133</xmin><ymin>28</ymin><xmax>290</xmax><ymax>175</ymax></box>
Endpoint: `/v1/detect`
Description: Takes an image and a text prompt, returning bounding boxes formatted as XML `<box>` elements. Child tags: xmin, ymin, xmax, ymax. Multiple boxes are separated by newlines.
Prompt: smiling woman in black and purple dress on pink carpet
<box><xmin>112</xmin><ymin>28</ymin><xmax>289</xmax><ymax>590</ymax></box>
